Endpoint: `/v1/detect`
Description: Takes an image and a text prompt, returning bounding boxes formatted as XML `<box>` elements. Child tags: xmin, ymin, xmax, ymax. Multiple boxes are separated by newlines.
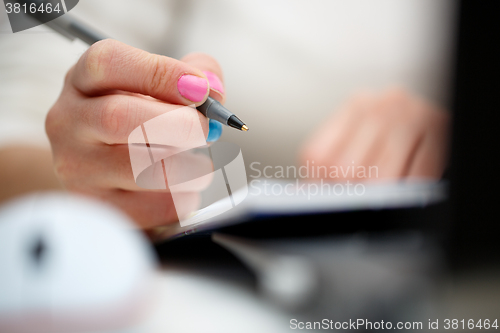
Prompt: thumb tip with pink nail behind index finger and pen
<box><xmin>181</xmin><ymin>53</ymin><xmax>226</xmax><ymax>104</ymax></box>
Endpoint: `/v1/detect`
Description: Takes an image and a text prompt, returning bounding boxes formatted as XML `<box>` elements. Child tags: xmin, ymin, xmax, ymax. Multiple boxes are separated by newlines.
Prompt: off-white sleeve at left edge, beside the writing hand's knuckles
<box><xmin>0</xmin><ymin>27</ymin><xmax>85</xmax><ymax>146</ymax></box>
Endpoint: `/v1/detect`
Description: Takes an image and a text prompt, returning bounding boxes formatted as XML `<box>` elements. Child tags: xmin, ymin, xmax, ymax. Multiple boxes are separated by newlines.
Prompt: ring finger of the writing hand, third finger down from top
<box><xmin>55</xmin><ymin>141</ymin><xmax>213</xmax><ymax>192</ymax></box>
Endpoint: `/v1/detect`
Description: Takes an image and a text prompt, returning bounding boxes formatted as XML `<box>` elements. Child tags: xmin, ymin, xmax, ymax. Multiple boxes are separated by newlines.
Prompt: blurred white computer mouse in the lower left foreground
<box><xmin>0</xmin><ymin>193</ymin><xmax>156</xmax><ymax>333</ymax></box>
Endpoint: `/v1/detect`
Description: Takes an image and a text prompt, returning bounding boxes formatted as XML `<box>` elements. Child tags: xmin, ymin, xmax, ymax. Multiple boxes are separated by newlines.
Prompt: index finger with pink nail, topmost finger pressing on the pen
<box><xmin>68</xmin><ymin>39</ymin><xmax>209</xmax><ymax>105</ymax></box>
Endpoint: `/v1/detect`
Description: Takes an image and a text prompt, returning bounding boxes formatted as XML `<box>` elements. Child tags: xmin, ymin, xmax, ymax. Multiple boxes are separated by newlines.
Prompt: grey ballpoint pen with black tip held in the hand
<box><xmin>20</xmin><ymin>0</ymin><xmax>248</xmax><ymax>131</ymax></box>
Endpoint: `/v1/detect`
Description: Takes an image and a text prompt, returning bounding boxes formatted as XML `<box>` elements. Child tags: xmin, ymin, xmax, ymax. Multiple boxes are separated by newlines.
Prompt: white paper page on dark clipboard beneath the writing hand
<box><xmin>152</xmin><ymin>179</ymin><xmax>446</xmax><ymax>239</ymax></box>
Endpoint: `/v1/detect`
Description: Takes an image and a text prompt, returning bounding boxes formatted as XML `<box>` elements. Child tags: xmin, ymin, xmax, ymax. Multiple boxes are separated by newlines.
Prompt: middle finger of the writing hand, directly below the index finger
<box><xmin>74</xmin><ymin>94</ymin><xmax>208</xmax><ymax>147</ymax></box>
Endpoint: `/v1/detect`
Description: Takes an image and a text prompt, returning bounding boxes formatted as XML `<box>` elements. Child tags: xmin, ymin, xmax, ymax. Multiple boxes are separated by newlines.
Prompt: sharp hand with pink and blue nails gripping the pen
<box><xmin>46</xmin><ymin>40</ymin><xmax>225</xmax><ymax>229</ymax></box>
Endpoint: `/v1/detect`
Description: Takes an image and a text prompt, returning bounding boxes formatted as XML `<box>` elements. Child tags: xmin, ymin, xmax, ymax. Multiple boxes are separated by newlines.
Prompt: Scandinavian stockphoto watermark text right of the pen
<box><xmin>249</xmin><ymin>161</ymin><xmax>378</xmax><ymax>200</ymax></box>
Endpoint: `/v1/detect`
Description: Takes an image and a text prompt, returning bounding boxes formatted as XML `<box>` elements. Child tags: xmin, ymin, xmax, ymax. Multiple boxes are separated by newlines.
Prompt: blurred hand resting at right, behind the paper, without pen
<box><xmin>300</xmin><ymin>89</ymin><xmax>449</xmax><ymax>181</ymax></box>
